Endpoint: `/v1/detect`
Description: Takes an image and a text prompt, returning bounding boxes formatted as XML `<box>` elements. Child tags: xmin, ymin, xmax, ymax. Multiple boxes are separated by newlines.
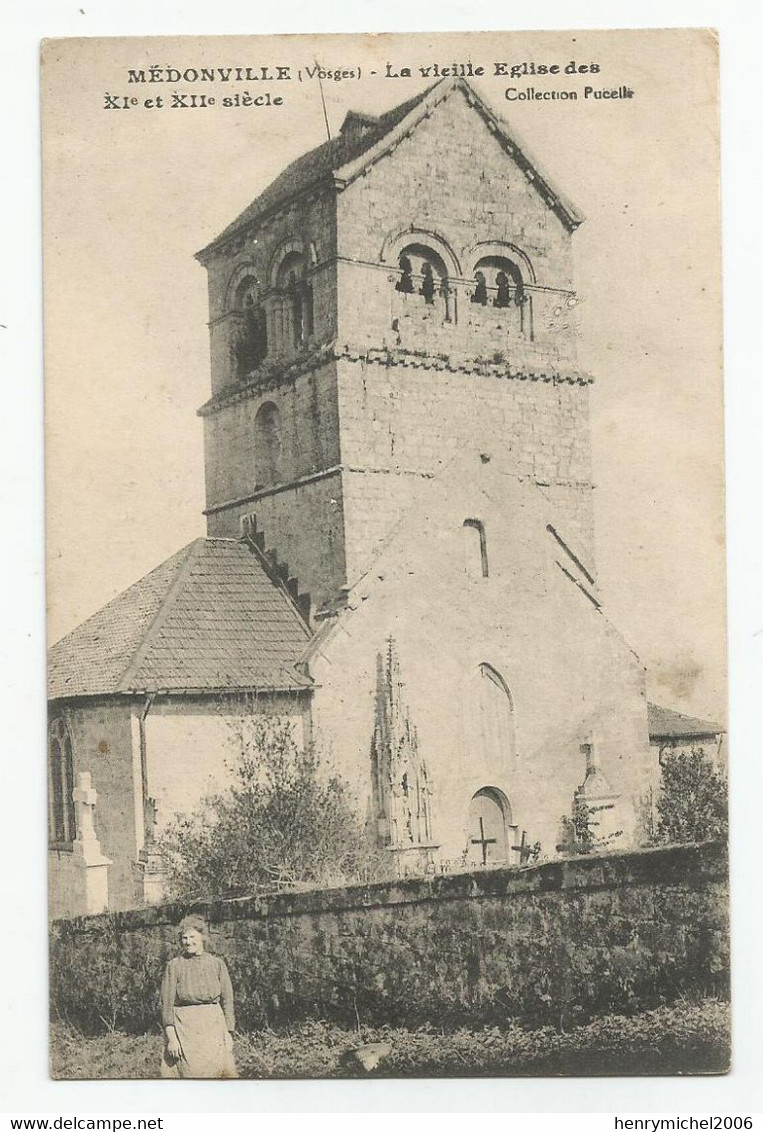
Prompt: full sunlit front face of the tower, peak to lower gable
<box><xmin>330</xmin><ymin>84</ymin><xmax>594</xmax><ymax>581</ymax></box>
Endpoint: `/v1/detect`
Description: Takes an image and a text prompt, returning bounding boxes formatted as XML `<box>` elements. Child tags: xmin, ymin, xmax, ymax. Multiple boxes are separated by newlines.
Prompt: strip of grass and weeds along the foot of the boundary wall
<box><xmin>51</xmin><ymin>1000</ymin><xmax>730</xmax><ymax>1080</ymax></box>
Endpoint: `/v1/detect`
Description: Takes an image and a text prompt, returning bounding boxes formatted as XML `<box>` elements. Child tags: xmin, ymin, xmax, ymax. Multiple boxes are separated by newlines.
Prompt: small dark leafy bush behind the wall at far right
<box><xmin>654</xmin><ymin>747</ymin><xmax>729</xmax><ymax>844</ymax></box>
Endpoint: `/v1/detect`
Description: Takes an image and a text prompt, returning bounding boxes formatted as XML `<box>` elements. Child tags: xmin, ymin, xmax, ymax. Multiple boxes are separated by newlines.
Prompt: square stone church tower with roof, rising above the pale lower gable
<box><xmin>198</xmin><ymin>79</ymin><xmax>593</xmax><ymax>618</ymax></box>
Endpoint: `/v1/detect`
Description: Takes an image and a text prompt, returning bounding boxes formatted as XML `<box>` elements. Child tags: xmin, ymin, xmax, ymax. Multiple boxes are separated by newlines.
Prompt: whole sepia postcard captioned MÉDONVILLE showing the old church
<box><xmin>42</xmin><ymin>29</ymin><xmax>730</xmax><ymax>1079</ymax></box>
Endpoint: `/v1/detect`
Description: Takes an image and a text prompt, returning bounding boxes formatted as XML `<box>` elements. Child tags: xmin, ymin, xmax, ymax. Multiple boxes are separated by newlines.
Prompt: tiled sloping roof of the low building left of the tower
<box><xmin>48</xmin><ymin>539</ymin><xmax>311</xmax><ymax>700</ymax></box>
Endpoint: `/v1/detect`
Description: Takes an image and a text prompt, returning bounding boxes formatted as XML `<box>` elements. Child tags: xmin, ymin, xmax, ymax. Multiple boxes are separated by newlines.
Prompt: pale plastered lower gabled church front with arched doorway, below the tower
<box><xmin>311</xmin><ymin>464</ymin><xmax>649</xmax><ymax>867</ymax></box>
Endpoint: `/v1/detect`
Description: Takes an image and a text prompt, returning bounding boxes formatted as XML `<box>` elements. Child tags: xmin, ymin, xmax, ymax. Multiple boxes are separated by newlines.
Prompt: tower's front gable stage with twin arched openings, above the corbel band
<box><xmin>337</xmin><ymin>91</ymin><xmax>575</xmax><ymax>363</ymax></box>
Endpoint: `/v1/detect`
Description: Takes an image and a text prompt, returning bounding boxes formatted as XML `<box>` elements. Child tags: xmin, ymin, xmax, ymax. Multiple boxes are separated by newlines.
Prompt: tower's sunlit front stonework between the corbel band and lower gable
<box><xmin>337</xmin><ymin>360</ymin><xmax>594</xmax><ymax>582</ymax></box>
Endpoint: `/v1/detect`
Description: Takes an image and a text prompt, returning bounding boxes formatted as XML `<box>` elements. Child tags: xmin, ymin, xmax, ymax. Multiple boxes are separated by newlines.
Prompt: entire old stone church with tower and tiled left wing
<box><xmin>50</xmin><ymin>79</ymin><xmax>665</xmax><ymax>915</ymax></box>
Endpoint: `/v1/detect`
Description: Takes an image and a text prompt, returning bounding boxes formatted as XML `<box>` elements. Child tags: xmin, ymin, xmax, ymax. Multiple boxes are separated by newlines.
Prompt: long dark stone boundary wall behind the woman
<box><xmin>51</xmin><ymin>843</ymin><xmax>728</xmax><ymax>1029</ymax></box>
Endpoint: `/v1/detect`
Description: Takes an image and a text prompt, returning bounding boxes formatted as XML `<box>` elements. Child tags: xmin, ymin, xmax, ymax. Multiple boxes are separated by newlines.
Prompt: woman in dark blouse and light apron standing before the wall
<box><xmin>161</xmin><ymin>916</ymin><xmax>238</xmax><ymax>1078</ymax></box>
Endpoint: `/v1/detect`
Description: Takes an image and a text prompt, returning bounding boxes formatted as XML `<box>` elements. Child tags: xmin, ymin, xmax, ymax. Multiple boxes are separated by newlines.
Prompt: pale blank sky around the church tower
<box><xmin>43</xmin><ymin>31</ymin><xmax>726</xmax><ymax>720</ymax></box>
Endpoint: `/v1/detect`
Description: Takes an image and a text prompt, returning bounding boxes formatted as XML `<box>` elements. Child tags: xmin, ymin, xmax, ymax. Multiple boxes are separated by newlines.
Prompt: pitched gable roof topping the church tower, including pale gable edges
<box><xmin>198</xmin><ymin>78</ymin><xmax>583</xmax><ymax>263</ymax></box>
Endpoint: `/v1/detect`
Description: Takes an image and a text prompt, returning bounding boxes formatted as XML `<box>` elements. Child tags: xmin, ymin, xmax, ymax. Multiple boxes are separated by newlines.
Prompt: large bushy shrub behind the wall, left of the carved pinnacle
<box><xmin>158</xmin><ymin>717</ymin><xmax>386</xmax><ymax>900</ymax></box>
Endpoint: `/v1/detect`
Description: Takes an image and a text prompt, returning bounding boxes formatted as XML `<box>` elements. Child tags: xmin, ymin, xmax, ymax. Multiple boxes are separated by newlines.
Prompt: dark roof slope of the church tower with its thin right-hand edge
<box><xmin>198</xmin><ymin>78</ymin><xmax>582</xmax><ymax>259</ymax></box>
